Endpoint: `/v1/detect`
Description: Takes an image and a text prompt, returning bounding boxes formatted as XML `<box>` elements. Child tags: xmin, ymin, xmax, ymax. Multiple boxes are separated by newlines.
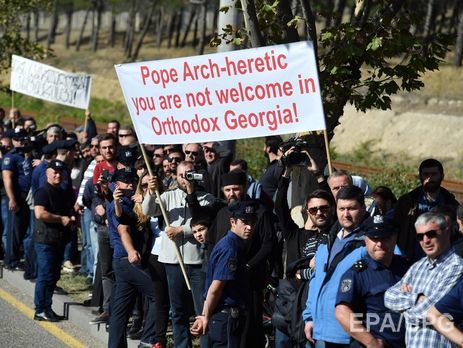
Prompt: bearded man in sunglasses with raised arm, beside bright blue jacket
<box><xmin>272</xmin><ymin>160</ymin><xmax>336</xmax><ymax>348</ymax></box>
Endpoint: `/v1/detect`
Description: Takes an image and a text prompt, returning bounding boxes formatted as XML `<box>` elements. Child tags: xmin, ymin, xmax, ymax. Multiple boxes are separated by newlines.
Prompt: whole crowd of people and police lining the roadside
<box><xmin>0</xmin><ymin>109</ymin><xmax>463</xmax><ymax>348</ymax></box>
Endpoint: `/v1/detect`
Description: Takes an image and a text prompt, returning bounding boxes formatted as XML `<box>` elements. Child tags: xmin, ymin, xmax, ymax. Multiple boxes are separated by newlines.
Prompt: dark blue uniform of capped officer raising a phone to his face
<box><xmin>106</xmin><ymin>197</ymin><xmax>155</xmax><ymax>348</ymax></box>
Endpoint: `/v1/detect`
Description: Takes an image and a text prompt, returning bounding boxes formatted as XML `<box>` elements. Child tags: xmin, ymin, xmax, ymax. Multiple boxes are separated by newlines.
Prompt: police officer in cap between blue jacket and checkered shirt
<box><xmin>336</xmin><ymin>215</ymin><xmax>408</xmax><ymax>347</ymax></box>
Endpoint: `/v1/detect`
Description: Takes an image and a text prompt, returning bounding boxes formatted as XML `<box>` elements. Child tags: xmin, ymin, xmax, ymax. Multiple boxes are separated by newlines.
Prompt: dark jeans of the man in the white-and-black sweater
<box><xmin>164</xmin><ymin>263</ymin><xmax>206</xmax><ymax>348</ymax></box>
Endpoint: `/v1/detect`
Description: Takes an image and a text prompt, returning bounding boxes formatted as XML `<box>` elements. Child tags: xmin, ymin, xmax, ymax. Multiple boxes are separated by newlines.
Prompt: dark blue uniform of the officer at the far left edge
<box><xmin>2</xmin><ymin>148</ymin><xmax>32</xmax><ymax>268</ymax></box>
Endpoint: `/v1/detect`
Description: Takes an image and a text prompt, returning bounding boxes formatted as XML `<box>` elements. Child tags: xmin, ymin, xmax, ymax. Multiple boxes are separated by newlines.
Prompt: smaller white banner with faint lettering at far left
<box><xmin>10</xmin><ymin>55</ymin><xmax>92</xmax><ymax>109</ymax></box>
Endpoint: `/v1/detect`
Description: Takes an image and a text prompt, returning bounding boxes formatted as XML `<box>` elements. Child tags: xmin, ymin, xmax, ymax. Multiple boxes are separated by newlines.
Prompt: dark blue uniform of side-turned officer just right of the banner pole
<box><xmin>204</xmin><ymin>231</ymin><xmax>251</xmax><ymax>347</ymax></box>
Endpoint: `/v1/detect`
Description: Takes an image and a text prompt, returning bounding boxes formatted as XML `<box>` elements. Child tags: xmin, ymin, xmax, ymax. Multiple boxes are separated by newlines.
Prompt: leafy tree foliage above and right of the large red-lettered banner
<box><xmin>212</xmin><ymin>0</ymin><xmax>450</xmax><ymax>138</ymax></box>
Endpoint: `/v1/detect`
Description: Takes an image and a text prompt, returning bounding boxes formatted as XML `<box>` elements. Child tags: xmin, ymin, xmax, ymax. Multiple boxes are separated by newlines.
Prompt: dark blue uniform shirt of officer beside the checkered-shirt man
<box><xmin>336</xmin><ymin>255</ymin><xmax>408</xmax><ymax>348</ymax></box>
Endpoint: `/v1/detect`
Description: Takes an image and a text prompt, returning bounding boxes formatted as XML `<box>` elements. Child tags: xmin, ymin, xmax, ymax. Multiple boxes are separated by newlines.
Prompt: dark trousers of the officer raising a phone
<box><xmin>108</xmin><ymin>257</ymin><xmax>156</xmax><ymax>348</ymax></box>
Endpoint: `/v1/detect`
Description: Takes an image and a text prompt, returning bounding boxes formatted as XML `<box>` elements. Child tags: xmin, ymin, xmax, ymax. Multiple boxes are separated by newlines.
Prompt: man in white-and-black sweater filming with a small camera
<box><xmin>142</xmin><ymin>161</ymin><xmax>215</xmax><ymax>348</ymax></box>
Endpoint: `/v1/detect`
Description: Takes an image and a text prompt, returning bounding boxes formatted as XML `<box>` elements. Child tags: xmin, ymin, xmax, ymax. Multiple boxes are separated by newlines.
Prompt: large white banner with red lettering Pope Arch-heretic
<box><xmin>115</xmin><ymin>42</ymin><xmax>326</xmax><ymax>144</ymax></box>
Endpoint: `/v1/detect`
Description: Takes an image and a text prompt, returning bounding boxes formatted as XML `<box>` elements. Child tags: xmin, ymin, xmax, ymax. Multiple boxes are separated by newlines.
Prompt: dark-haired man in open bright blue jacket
<box><xmin>303</xmin><ymin>186</ymin><xmax>372</xmax><ymax>347</ymax></box>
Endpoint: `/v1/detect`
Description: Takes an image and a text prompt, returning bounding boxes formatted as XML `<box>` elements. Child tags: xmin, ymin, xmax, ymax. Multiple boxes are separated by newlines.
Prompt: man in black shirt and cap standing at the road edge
<box><xmin>34</xmin><ymin>159</ymin><xmax>75</xmax><ymax>321</ymax></box>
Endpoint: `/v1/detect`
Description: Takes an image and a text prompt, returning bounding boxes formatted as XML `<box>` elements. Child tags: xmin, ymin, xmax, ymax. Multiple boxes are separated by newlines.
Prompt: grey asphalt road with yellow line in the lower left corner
<box><xmin>0</xmin><ymin>279</ymin><xmax>105</xmax><ymax>348</ymax></box>
